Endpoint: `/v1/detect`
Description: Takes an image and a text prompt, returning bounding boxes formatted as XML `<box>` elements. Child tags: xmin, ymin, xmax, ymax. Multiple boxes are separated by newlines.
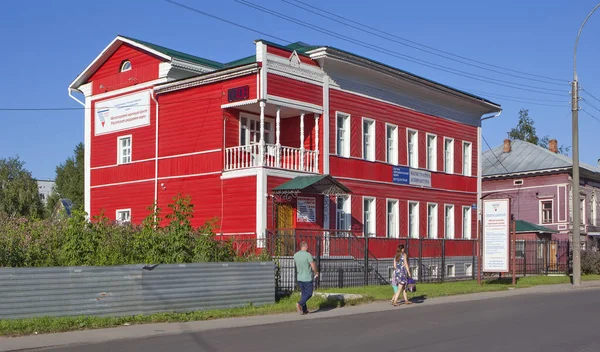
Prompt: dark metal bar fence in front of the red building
<box><xmin>266</xmin><ymin>230</ymin><xmax>477</xmax><ymax>292</ymax></box>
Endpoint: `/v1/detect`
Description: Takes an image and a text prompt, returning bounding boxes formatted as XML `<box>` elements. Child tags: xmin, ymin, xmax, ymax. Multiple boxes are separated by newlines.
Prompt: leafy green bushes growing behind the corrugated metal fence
<box><xmin>0</xmin><ymin>196</ymin><xmax>270</xmax><ymax>267</ymax></box>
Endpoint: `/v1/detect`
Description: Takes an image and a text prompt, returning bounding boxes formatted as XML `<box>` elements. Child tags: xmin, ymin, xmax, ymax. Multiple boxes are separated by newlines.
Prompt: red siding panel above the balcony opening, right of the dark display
<box><xmin>267</xmin><ymin>73</ymin><xmax>323</xmax><ymax>106</ymax></box>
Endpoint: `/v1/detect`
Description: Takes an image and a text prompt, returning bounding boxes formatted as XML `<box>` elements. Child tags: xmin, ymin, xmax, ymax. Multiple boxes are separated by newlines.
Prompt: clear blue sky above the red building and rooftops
<box><xmin>0</xmin><ymin>0</ymin><xmax>600</xmax><ymax>179</ymax></box>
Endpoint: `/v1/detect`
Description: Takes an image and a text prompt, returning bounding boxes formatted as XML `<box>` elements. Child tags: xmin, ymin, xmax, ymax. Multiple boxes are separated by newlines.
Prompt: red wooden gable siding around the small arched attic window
<box><xmin>88</xmin><ymin>44</ymin><xmax>162</xmax><ymax>94</ymax></box>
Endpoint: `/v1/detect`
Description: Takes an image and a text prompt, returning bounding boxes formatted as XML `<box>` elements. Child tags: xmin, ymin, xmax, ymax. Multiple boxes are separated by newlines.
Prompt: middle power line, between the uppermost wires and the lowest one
<box><xmin>235</xmin><ymin>0</ymin><xmax>562</xmax><ymax>96</ymax></box>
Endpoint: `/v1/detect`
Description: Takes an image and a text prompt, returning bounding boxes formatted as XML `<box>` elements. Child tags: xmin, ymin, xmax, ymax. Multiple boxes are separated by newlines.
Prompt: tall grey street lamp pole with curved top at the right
<box><xmin>571</xmin><ymin>4</ymin><xmax>600</xmax><ymax>286</ymax></box>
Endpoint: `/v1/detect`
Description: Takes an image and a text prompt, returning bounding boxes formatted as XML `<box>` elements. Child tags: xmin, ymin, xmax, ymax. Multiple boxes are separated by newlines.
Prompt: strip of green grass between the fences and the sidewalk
<box><xmin>0</xmin><ymin>275</ymin><xmax>600</xmax><ymax>336</ymax></box>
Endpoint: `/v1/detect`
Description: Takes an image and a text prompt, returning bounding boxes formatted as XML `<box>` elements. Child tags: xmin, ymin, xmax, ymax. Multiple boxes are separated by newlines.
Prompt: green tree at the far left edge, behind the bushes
<box><xmin>0</xmin><ymin>156</ymin><xmax>44</xmax><ymax>218</ymax></box>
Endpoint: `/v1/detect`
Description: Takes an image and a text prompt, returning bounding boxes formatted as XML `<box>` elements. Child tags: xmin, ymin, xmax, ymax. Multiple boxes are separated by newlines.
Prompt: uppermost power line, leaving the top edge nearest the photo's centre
<box><xmin>281</xmin><ymin>0</ymin><xmax>567</xmax><ymax>85</ymax></box>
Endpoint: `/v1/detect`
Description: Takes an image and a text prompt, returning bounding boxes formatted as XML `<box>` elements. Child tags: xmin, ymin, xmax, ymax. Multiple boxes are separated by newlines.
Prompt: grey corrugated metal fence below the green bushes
<box><xmin>0</xmin><ymin>262</ymin><xmax>275</xmax><ymax>319</ymax></box>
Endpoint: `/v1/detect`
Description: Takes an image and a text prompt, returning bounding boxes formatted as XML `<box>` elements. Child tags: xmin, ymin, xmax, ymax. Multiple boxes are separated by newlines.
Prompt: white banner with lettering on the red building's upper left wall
<box><xmin>94</xmin><ymin>91</ymin><xmax>150</xmax><ymax>136</ymax></box>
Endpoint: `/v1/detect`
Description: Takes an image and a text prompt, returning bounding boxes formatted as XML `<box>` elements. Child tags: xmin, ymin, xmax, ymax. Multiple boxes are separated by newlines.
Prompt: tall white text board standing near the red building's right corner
<box><xmin>483</xmin><ymin>199</ymin><xmax>510</xmax><ymax>273</ymax></box>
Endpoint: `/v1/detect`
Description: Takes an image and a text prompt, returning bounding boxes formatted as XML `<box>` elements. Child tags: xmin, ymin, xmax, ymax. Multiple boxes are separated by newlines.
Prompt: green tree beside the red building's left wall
<box><xmin>48</xmin><ymin>143</ymin><xmax>84</xmax><ymax>212</ymax></box>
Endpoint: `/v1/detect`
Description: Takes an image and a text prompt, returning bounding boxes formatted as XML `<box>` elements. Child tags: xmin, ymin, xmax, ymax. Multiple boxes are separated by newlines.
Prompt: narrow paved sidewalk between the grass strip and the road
<box><xmin>0</xmin><ymin>281</ymin><xmax>600</xmax><ymax>351</ymax></box>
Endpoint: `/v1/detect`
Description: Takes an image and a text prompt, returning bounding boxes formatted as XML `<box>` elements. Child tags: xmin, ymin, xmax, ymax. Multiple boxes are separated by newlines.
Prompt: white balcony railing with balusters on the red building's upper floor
<box><xmin>225</xmin><ymin>144</ymin><xmax>319</xmax><ymax>173</ymax></box>
